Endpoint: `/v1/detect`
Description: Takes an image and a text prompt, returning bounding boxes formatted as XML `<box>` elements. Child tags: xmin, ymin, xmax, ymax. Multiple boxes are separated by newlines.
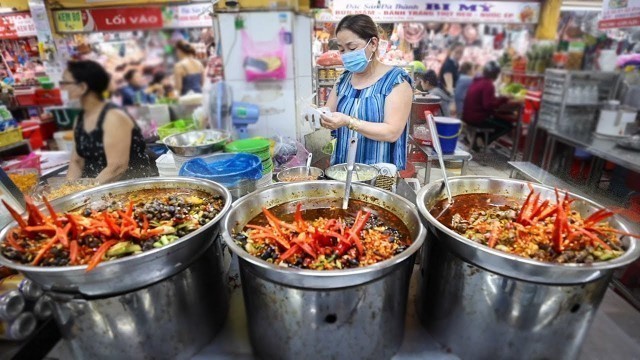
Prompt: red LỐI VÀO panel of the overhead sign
<box><xmin>82</xmin><ymin>6</ymin><xmax>162</xmax><ymax>31</ymax></box>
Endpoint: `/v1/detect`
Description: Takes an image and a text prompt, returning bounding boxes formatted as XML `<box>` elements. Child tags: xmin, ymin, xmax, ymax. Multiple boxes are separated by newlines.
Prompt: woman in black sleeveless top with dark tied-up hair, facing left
<box><xmin>60</xmin><ymin>61</ymin><xmax>158</xmax><ymax>183</ymax></box>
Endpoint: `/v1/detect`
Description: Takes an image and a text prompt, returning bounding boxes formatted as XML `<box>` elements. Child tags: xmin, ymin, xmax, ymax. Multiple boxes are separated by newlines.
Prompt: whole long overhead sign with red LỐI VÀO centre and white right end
<box><xmin>53</xmin><ymin>4</ymin><xmax>212</xmax><ymax>33</ymax></box>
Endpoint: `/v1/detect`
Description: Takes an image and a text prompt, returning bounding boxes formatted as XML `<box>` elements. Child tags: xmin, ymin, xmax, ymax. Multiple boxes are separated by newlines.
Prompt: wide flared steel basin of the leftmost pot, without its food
<box><xmin>0</xmin><ymin>177</ymin><xmax>231</xmax><ymax>296</ymax></box>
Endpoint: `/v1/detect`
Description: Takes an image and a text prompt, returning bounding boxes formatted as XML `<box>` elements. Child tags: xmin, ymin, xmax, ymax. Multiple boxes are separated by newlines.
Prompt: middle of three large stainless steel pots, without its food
<box><xmin>222</xmin><ymin>181</ymin><xmax>425</xmax><ymax>359</ymax></box>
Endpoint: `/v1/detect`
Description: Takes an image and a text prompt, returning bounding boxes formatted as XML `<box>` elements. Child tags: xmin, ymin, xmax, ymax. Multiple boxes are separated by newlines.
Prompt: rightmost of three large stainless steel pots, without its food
<box><xmin>416</xmin><ymin>176</ymin><xmax>640</xmax><ymax>359</ymax></box>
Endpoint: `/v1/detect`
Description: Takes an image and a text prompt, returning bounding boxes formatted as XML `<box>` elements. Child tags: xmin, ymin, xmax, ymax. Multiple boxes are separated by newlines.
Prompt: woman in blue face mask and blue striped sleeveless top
<box><xmin>321</xmin><ymin>15</ymin><xmax>413</xmax><ymax>170</ymax></box>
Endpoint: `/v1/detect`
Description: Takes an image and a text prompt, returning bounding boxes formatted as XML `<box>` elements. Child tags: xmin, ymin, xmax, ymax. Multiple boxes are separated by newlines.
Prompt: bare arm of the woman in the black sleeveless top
<box><xmin>96</xmin><ymin>110</ymin><xmax>133</xmax><ymax>184</ymax></box>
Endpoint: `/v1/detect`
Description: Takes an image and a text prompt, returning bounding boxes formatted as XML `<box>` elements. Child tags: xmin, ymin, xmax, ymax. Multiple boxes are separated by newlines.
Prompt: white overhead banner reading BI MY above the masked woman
<box><xmin>316</xmin><ymin>0</ymin><xmax>540</xmax><ymax>24</ymax></box>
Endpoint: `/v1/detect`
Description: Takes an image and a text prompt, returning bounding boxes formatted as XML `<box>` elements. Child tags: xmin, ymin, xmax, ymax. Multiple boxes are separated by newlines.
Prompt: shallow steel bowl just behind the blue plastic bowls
<box><xmin>163</xmin><ymin>130</ymin><xmax>231</xmax><ymax>156</ymax></box>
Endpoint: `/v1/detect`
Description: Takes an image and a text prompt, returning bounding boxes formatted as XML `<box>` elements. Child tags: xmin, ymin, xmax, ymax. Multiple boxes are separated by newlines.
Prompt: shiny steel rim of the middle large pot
<box><xmin>220</xmin><ymin>180</ymin><xmax>426</xmax><ymax>278</ymax></box>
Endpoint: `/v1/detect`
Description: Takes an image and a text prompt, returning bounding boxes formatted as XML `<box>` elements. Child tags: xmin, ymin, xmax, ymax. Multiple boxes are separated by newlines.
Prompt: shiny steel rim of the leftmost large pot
<box><xmin>0</xmin><ymin>177</ymin><xmax>231</xmax><ymax>274</ymax></box>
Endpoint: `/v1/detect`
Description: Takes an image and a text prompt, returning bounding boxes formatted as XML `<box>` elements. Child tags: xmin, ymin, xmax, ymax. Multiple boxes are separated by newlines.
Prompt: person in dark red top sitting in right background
<box><xmin>462</xmin><ymin>61</ymin><xmax>513</xmax><ymax>148</ymax></box>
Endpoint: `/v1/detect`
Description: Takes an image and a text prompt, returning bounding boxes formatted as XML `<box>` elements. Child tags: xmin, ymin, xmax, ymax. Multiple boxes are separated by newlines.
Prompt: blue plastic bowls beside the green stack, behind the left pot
<box><xmin>179</xmin><ymin>153</ymin><xmax>262</xmax><ymax>199</ymax></box>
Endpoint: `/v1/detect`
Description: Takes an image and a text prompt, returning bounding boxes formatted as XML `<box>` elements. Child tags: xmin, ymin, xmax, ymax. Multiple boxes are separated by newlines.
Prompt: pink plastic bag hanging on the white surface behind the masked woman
<box><xmin>242</xmin><ymin>30</ymin><xmax>287</xmax><ymax>81</ymax></box>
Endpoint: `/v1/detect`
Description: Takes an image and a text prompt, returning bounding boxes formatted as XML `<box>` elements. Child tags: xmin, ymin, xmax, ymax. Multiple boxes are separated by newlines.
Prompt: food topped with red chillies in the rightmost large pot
<box><xmin>431</xmin><ymin>184</ymin><xmax>640</xmax><ymax>263</ymax></box>
